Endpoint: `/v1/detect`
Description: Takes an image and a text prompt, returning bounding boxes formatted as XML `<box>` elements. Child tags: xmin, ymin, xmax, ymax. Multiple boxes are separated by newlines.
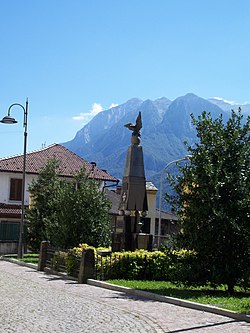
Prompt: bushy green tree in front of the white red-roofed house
<box><xmin>27</xmin><ymin>160</ymin><xmax>111</xmax><ymax>249</ymax></box>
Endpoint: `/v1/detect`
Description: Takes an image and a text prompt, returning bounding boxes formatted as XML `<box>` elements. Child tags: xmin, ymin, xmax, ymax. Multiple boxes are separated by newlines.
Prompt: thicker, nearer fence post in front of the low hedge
<box><xmin>78</xmin><ymin>249</ymin><xmax>95</xmax><ymax>283</ymax></box>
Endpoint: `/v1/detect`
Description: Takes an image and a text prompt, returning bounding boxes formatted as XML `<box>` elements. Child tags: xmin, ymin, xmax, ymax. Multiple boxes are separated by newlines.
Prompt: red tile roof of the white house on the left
<box><xmin>0</xmin><ymin>144</ymin><xmax>118</xmax><ymax>182</ymax></box>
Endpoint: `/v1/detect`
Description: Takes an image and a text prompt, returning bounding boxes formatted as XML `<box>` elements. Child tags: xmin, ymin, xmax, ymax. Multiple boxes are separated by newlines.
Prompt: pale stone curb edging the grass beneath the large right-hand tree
<box><xmin>87</xmin><ymin>279</ymin><xmax>250</xmax><ymax>323</ymax></box>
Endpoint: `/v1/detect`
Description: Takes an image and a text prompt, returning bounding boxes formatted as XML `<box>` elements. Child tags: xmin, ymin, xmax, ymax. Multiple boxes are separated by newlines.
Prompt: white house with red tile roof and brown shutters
<box><xmin>0</xmin><ymin>144</ymin><xmax>118</xmax><ymax>254</ymax></box>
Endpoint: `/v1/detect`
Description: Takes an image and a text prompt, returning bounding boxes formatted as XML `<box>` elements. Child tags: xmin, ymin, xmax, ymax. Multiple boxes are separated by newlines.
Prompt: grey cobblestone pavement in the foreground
<box><xmin>0</xmin><ymin>261</ymin><xmax>250</xmax><ymax>333</ymax></box>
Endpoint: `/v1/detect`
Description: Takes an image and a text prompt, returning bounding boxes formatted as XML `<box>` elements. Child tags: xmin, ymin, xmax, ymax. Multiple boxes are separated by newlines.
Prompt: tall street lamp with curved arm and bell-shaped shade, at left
<box><xmin>0</xmin><ymin>98</ymin><xmax>28</xmax><ymax>258</ymax></box>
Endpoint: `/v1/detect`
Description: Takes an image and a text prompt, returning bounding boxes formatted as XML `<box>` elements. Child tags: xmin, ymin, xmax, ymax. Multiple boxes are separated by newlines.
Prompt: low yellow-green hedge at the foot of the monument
<box><xmin>47</xmin><ymin>244</ymin><xmax>202</xmax><ymax>285</ymax></box>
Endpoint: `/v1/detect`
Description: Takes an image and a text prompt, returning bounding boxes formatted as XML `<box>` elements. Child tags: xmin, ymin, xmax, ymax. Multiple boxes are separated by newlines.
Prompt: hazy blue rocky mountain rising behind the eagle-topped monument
<box><xmin>63</xmin><ymin>93</ymin><xmax>234</xmax><ymax>184</ymax></box>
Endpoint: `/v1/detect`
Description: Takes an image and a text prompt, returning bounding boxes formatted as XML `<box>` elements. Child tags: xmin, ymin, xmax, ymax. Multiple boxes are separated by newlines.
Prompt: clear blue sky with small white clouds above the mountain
<box><xmin>0</xmin><ymin>0</ymin><xmax>250</xmax><ymax>157</ymax></box>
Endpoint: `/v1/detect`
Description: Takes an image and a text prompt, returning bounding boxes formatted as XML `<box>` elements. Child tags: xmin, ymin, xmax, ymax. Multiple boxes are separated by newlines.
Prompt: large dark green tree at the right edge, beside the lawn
<box><xmin>168</xmin><ymin>109</ymin><xmax>250</xmax><ymax>292</ymax></box>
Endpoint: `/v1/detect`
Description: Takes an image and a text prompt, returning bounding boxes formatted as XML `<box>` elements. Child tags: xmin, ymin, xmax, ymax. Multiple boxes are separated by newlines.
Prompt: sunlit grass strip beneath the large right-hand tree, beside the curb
<box><xmin>106</xmin><ymin>280</ymin><xmax>250</xmax><ymax>314</ymax></box>
